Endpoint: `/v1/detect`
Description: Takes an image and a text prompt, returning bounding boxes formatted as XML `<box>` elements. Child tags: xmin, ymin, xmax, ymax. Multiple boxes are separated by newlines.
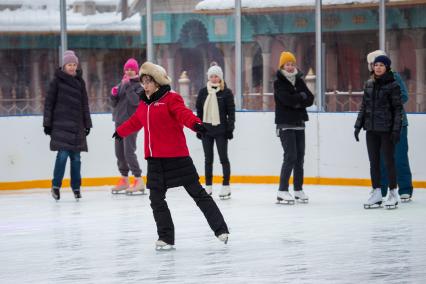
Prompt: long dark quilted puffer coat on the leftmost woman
<box><xmin>43</xmin><ymin>69</ymin><xmax>92</xmax><ymax>151</ymax></box>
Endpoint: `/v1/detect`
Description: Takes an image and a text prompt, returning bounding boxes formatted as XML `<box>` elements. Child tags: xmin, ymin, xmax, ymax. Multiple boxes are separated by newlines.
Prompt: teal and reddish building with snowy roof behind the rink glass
<box><xmin>0</xmin><ymin>0</ymin><xmax>426</xmax><ymax>115</ymax></box>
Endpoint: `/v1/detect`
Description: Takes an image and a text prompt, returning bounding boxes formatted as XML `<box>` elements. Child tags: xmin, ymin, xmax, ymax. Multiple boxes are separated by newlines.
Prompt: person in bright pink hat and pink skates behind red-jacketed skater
<box><xmin>111</xmin><ymin>58</ymin><xmax>145</xmax><ymax>194</ymax></box>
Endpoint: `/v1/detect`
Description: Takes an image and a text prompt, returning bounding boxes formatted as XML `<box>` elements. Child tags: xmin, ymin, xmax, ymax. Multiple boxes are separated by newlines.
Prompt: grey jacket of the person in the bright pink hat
<box><xmin>111</xmin><ymin>78</ymin><xmax>143</xmax><ymax>125</ymax></box>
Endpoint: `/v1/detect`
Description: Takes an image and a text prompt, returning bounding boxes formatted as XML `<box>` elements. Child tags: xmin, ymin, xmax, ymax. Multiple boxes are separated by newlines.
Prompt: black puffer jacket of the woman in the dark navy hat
<box><xmin>355</xmin><ymin>72</ymin><xmax>403</xmax><ymax>132</ymax></box>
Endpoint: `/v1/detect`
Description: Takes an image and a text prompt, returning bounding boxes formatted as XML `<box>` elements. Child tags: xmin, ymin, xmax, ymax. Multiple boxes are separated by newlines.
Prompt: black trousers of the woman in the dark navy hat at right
<box><xmin>366</xmin><ymin>131</ymin><xmax>397</xmax><ymax>189</ymax></box>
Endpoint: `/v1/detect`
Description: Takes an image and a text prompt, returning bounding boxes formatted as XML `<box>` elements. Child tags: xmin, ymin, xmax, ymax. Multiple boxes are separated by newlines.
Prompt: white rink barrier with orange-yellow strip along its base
<box><xmin>0</xmin><ymin>112</ymin><xmax>426</xmax><ymax>189</ymax></box>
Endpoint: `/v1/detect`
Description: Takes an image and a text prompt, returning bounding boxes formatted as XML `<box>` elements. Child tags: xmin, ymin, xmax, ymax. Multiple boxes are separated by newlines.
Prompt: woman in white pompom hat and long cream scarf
<box><xmin>196</xmin><ymin>62</ymin><xmax>235</xmax><ymax>199</ymax></box>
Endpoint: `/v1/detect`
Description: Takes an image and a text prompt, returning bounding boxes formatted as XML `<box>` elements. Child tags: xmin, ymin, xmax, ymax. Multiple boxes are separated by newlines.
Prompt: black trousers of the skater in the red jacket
<box><xmin>149</xmin><ymin>182</ymin><xmax>229</xmax><ymax>245</ymax></box>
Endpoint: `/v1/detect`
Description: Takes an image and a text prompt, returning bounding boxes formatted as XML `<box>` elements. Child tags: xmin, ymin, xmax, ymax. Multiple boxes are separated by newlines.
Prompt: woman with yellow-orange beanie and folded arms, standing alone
<box><xmin>274</xmin><ymin>52</ymin><xmax>314</xmax><ymax>204</ymax></box>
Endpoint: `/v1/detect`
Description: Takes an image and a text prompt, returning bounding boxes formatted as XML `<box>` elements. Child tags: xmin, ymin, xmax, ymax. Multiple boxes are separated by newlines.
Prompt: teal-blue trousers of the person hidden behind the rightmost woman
<box><xmin>380</xmin><ymin>126</ymin><xmax>413</xmax><ymax>196</ymax></box>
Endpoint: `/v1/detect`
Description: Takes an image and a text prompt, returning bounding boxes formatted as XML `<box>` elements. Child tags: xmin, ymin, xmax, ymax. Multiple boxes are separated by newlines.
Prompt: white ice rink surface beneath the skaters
<box><xmin>0</xmin><ymin>184</ymin><xmax>426</xmax><ymax>284</ymax></box>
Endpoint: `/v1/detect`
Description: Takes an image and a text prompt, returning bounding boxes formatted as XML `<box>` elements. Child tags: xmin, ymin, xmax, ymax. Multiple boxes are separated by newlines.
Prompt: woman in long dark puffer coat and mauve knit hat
<box><xmin>43</xmin><ymin>50</ymin><xmax>92</xmax><ymax>200</ymax></box>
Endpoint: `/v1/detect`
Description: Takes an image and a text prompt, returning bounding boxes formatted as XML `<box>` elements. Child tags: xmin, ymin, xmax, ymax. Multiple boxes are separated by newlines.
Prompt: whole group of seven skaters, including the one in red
<box><xmin>43</xmin><ymin>47</ymin><xmax>413</xmax><ymax>250</ymax></box>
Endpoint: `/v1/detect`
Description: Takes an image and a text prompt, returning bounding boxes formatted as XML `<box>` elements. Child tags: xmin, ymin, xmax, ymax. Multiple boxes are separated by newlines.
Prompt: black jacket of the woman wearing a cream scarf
<box><xmin>195</xmin><ymin>86</ymin><xmax>235</xmax><ymax>136</ymax></box>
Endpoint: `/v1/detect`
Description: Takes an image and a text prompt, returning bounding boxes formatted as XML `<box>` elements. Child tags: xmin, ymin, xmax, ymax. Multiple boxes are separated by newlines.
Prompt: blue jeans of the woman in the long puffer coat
<box><xmin>52</xmin><ymin>150</ymin><xmax>81</xmax><ymax>190</ymax></box>
